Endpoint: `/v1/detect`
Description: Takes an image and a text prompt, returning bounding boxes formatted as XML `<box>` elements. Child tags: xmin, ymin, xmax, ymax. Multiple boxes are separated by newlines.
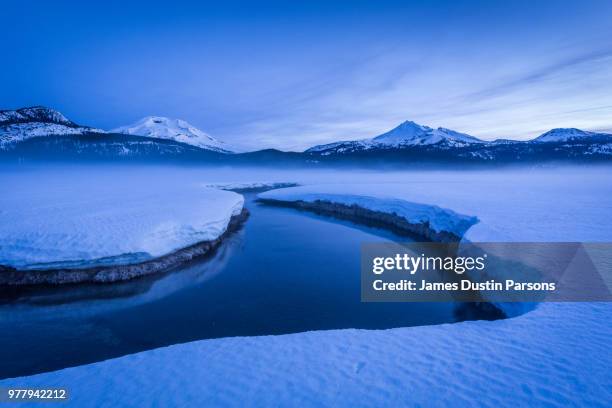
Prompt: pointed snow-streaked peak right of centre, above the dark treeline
<box><xmin>306</xmin><ymin>121</ymin><xmax>486</xmax><ymax>154</ymax></box>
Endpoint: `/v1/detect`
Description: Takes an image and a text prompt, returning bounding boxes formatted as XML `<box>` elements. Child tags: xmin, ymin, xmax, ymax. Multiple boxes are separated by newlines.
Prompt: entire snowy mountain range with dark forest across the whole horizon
<box><xmin>0</xmin><ymin>106</ymin><xmax>612</xmax><ymax>166</ymax></box>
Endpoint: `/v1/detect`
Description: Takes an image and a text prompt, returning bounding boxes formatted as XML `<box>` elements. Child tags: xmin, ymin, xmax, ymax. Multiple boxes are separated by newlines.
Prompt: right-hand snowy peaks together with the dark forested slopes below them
<box><xmin>304</xmin><ymin>121</ymin><xmax>612</xmax><ymax>165</ymax></box>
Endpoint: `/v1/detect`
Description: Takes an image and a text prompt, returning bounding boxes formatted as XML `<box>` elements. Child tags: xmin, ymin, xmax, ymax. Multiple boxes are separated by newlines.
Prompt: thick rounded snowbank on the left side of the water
<box><xmin>0</xmin><ymin>179</ymin><xmax>243</xmax><ymax>269</ymax></box>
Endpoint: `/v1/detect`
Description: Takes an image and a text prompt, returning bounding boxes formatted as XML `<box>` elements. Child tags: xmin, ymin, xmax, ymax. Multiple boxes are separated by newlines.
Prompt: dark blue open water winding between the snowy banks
<box><xmin>0</xmin><ymin>194</ymin><xmax>494</xmax><ymax>378</ymax></box>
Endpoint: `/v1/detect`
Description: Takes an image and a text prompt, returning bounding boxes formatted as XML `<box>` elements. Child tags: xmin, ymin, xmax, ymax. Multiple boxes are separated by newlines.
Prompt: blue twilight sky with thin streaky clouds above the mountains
<box><xmin>0</xmin><ymin>0</ymin><xmax>612</xmax><ymax>149</ymax></box>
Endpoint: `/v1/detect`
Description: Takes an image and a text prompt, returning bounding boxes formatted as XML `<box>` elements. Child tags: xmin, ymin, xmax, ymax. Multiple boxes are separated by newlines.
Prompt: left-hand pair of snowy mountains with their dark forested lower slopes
<box><xmin>0</xmin><ymin>106</ymin><xmax>229</xmax><ymax>162</ymax></box>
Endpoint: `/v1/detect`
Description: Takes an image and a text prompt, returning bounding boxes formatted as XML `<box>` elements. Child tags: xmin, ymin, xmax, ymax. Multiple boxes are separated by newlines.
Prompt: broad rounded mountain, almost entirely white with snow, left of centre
<box><xmin>112</xmin><ymin>116</ymin><xmax>231</xmax><ymax>153</ymax></box>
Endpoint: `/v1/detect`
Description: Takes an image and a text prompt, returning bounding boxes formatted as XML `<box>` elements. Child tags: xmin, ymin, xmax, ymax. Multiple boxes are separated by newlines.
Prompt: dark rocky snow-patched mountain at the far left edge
<box><xmin>0</xmin><ymin>106</ymin><xmax>104</xmax><ymax>149</ymax></box>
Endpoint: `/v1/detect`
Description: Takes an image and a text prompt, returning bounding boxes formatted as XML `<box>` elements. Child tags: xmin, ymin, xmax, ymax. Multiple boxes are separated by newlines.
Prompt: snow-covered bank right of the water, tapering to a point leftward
<box><xmin>259</xmin><ymin>169</ymin><xmax>612</xmax><ymax>242</ymax></box>
